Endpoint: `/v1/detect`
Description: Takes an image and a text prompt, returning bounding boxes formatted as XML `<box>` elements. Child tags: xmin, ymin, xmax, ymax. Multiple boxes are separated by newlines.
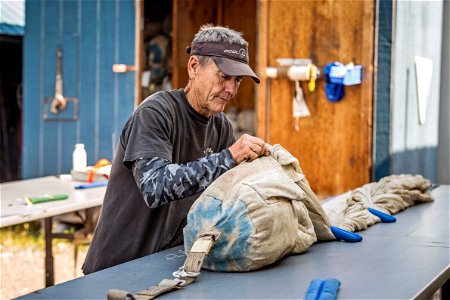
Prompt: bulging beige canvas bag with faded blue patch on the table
<box><xmin>183</xmin><ymin>145</ymin><xmax>335</xmax><ymax>271</ymax></box>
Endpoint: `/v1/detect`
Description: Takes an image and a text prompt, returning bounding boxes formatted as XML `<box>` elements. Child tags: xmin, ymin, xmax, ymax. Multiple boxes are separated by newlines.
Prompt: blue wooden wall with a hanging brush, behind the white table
<box><xmin>22</xmin><ymin>0</ymin><xmax>135</xmax><ymax>179</ymax></box>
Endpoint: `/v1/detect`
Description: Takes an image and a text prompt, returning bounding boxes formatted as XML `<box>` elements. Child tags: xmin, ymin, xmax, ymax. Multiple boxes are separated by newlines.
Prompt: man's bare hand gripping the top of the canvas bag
<box><xmin>228</xmin><ymin>134</ymin><xmax>270</xmax><ymax>164</ymax></box>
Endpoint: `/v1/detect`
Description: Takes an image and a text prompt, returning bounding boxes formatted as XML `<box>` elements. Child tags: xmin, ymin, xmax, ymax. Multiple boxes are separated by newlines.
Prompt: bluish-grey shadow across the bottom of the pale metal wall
<box><xmin>390</xmin><ymin>147</ymin><xmax>436</xmax><ymax>183</ymax></box>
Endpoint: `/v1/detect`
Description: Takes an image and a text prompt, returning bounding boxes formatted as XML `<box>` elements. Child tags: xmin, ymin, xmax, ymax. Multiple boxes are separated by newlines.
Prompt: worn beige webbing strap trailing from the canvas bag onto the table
<box><xmin>107</xmin><ymin>231</ymin><xmax>220</xmax><ymax>300</ymax></box>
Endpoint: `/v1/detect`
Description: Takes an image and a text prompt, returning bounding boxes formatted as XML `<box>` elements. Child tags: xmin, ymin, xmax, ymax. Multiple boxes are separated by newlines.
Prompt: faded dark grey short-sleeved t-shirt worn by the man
<box><xmin>83</xmin><ymin>89</ymin><xmax>234</xmax><ymax>274</ymax></box>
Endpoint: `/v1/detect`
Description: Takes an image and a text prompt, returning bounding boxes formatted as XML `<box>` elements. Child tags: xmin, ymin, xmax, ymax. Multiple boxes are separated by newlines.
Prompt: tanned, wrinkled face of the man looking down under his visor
<box><xmin>192</xmin><ymin>60</ymin><xmax>242</xmax><ymax>117</ymax></box>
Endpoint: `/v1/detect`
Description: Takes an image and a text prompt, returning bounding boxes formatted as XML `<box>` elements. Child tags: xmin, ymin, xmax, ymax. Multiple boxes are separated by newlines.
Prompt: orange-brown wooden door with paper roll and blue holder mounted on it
<box><xmin>256</xmin><ymin>0</ymin><xmax>375</xmax><ymax>197</ymax></box>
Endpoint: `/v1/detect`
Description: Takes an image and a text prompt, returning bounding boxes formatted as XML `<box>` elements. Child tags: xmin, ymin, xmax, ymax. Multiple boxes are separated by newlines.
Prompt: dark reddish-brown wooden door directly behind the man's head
<box><xmin>172</xmin><ymin>0</ymin><xmax>257</xmax><ymax>110</ymax></box>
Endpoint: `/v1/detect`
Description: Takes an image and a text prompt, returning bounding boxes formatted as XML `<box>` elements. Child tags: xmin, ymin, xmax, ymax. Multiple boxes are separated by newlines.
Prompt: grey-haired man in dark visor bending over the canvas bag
<box><xmin>83</xmin><ymin>25</ymin><xmax>269</xmax><ymax>274</ymax></box>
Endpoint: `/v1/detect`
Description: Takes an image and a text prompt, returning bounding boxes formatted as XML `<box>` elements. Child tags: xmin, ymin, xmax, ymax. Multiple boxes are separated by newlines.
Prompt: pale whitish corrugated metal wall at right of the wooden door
<box><xmin>391</xmin><ymin>1</ymin><xmax>443</xmax><ymax>181</ymax></box>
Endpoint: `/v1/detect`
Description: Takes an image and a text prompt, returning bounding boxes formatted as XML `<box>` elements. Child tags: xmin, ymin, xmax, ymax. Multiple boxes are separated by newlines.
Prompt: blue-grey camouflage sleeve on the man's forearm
<box><xmin>132</xmin><ymin>149</ymin><xmax>236</xmax><ymax>208</ymax></box>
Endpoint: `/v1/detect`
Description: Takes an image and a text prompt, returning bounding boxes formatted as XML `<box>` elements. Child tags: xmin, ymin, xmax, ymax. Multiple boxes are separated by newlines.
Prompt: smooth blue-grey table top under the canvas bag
<box><xmin>20</xmin><ymin>186</ymin><xmax>450</xmax><ymax>299</ymax></box>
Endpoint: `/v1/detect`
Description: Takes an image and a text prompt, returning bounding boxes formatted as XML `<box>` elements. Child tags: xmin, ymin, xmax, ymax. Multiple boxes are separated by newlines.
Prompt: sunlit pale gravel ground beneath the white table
<box><xmin>0</xmin><ymin>241</ymin><xmax>87</xmax><ymax>299</ymax></box>
